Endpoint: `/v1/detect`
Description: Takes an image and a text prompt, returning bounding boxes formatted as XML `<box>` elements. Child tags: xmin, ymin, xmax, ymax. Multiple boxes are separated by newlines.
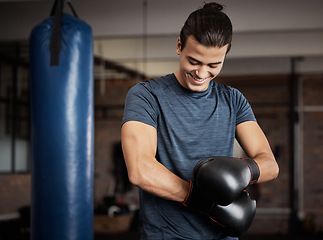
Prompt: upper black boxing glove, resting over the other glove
<box><xmin>193</xmin><ymin>157</ymin><xmax>260</xmax><ymax>206</ymax></box>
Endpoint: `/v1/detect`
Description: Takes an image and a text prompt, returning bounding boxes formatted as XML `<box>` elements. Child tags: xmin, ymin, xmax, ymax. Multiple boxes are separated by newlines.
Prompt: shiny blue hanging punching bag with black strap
<box><xmin>30</xmin><ymin>0</ymin><xmax>94</xmax><ymax>240</ymax></box>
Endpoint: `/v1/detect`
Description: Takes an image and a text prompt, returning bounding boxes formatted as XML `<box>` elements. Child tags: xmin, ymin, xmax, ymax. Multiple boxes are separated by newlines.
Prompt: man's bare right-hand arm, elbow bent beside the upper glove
<box><xmin>236</xmin><ymin>121</ymin><xmax>279</xmax><ymax>182</ymax></box>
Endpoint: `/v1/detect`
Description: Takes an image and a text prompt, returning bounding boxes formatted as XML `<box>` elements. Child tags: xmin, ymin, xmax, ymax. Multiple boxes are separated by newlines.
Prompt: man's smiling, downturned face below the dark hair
<box><xmin>175</xmin><ymin>36</ymin><xmax>228</xmax><ymax>92</ymax></box>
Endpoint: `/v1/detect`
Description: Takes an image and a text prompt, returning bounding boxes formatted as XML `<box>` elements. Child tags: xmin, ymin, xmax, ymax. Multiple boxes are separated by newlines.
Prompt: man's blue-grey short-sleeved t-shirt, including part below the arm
<box><xmin>123</xmin><ymin>74</ymin><xmax>256</xmax><ymax>239</ymax></box>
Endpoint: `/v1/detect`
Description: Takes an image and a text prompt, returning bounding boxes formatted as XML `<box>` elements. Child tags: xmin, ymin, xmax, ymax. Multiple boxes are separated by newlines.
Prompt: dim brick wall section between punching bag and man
<box><xmin>94</xmin><ymin>79</ymin><xmax>139</xmax><ymax>208</ymax></box>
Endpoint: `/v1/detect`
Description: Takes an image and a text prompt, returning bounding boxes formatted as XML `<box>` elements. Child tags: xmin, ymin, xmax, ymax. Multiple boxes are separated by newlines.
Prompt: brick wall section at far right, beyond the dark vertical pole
<box><xmin>301</xmin><ymin>76</ymin><xmax>323</xmax><ymax>232</ymax></box>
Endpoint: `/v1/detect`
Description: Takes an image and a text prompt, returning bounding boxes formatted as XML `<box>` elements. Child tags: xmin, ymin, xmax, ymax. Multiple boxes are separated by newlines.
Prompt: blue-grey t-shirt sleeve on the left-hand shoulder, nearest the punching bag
<box><xmin>122</xmin><ymin>83</ymin><xmax>158</xmax><ymax>128</ymax></box>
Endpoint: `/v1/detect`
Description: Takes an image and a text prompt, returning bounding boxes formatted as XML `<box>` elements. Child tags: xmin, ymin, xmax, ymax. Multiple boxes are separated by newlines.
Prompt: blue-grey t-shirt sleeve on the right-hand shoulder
<box><xmin>234</xmin><ymin>89</ymin><xmax>256</xmax><ymax>126</ymax></box>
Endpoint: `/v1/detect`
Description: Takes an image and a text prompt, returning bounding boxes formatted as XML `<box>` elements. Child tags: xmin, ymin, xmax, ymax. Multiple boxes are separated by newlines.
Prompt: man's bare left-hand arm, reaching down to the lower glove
<box><xmin>121</xmin><ymin>121</ymin><xmax>189</xmax><ymax>202</ymax></box>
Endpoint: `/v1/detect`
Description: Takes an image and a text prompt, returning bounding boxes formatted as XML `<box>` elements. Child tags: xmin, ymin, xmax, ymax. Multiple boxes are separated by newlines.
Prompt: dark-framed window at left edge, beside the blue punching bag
<box><xmin>0</xmin><ymin>42</ymin><xmax>30</xmax><ymax>173</ymax></box>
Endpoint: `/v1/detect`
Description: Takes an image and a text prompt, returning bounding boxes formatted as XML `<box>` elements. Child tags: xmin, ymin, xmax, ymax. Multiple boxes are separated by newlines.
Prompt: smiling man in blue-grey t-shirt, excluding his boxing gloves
<box><xmin>121</xmin><ymin>3</ymin><xmax>278</xmax><ymax>239</ymax></box>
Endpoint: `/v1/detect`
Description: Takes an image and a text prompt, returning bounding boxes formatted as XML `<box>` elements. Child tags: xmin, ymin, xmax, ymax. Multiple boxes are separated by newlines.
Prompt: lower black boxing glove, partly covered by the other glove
<box><xmin>182</xmin><ymin>181</ymin><xmax>256</xmax><ymax>237</ymax></box>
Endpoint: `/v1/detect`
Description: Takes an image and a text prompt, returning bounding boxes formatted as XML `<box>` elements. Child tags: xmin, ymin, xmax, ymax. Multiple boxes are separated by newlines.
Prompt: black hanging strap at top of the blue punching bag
<box><xmin>50</xmin><ymin>0</ymin><xmax>78</xmax><ymax>66</ymax></box>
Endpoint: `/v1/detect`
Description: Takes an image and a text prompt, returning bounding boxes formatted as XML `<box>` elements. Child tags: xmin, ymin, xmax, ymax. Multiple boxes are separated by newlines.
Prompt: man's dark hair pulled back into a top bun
<box><xmin>180</xmin><ymin>2</ymin><xmax>232</xmax><ymax>52</ymax></box>
